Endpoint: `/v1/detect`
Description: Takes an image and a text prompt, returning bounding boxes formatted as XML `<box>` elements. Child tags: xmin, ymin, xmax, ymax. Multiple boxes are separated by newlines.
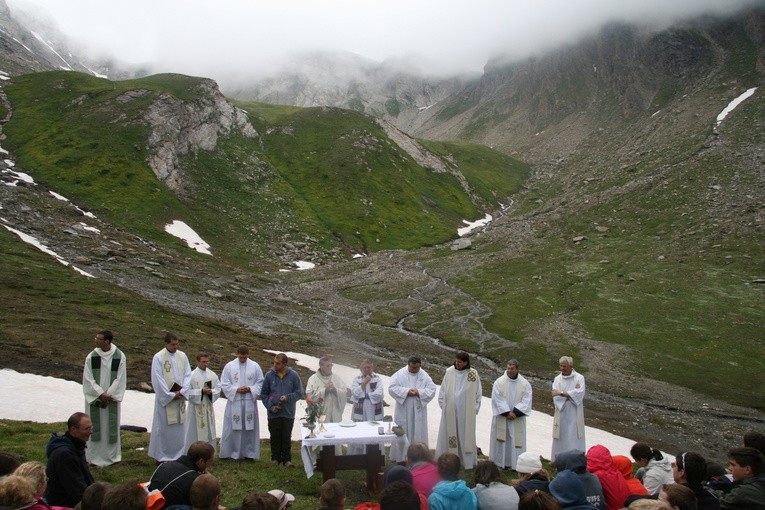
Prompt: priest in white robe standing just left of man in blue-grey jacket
<box><xmin>220</xmin><ymin>345</ymin><xmax>263</xmax><ymax>460</ymax></box>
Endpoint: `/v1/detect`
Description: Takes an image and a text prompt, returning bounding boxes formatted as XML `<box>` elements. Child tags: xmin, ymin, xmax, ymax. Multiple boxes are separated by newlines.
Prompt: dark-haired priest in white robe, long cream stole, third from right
<box><xmin>436</xmin><ymin>351</ymin><xmax>483</xmax><ymax>469</ymax></box>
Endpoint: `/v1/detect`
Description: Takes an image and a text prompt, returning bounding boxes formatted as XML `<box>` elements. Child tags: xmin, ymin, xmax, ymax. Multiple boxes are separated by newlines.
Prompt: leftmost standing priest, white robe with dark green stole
<box><xmin>82</xmin><ymin>330</ymin><xmax>127</xmax><ymax>467</ymax></box>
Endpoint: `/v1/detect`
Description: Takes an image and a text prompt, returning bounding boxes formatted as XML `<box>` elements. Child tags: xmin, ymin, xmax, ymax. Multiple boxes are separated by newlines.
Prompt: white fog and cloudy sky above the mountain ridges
<box><xmin>7</xmin><ymin>0</ymin><xmax>763</xmax><ymax>87</ymax></box>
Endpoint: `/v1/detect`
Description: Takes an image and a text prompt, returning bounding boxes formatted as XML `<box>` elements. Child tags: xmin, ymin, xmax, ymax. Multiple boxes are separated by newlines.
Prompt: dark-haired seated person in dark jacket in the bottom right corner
<box><xmin>720</xmin><ymin>447</ymin><xmax>765</xmax><ymax>510</ymax></box>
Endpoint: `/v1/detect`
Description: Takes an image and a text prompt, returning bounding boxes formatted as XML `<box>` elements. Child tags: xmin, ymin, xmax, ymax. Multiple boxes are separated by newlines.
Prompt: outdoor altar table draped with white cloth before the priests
<box><xmin>300</xmin><ymin>421</ymin><xmax>409</xmax><ymax>490</ymax></box>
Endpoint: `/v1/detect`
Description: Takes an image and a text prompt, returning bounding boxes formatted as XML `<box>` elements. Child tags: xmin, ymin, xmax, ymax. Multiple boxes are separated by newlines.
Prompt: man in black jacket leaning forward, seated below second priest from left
<box><xmin>149</xmin><ymin>441</ymin><xmax>215</xmax><ymax>508</ymax></box>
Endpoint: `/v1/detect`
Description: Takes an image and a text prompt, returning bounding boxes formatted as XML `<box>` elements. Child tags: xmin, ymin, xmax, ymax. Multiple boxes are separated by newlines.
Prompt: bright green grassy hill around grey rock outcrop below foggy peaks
<box><xmin>4</xmin><ymin>72</ymin><xmax>528</xmax><ymax>267</ymax></box>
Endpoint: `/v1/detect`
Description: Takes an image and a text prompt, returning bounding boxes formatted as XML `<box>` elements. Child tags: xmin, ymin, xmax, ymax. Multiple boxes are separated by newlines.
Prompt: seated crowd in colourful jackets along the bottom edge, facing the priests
<box><xmin>0</xmin><ymin>431</ymin><xmax>765</xmax><ymax>510</ymax></box>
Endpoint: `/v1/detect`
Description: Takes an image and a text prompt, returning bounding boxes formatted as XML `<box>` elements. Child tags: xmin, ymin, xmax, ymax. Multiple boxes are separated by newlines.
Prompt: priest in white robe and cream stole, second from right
<box><xmin>489</xmin><ymin>359</ymin><xmax>531</xmax><ymax>469</ymax></box>
